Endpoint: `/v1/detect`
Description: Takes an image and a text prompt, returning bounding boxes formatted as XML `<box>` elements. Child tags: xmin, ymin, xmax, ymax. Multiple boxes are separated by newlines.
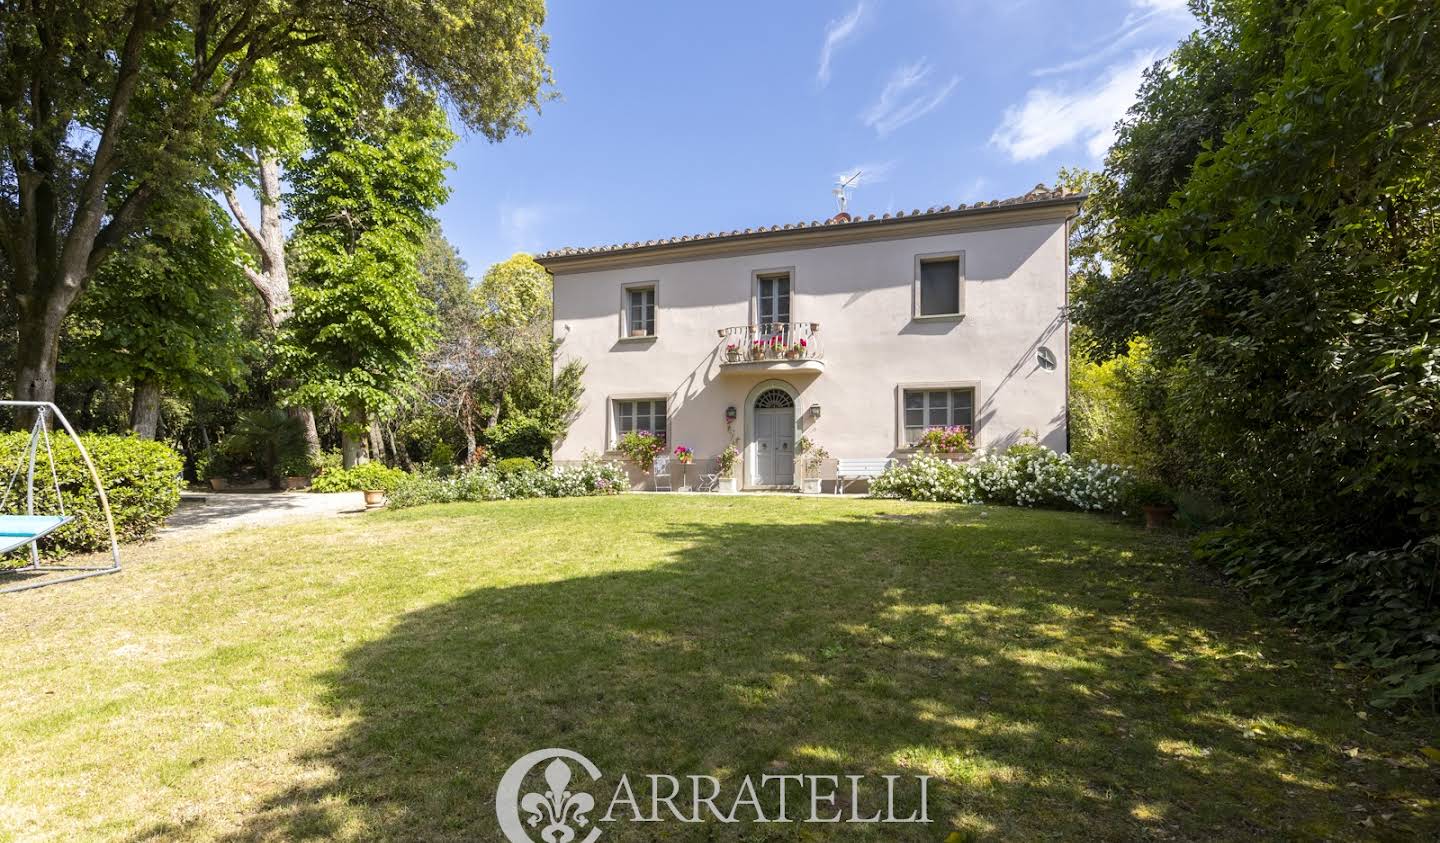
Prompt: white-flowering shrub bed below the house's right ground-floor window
<box><xmin>870</xmin><ymin>444</ymin><xmax>1133</xmax><ymax>512</ymax></box>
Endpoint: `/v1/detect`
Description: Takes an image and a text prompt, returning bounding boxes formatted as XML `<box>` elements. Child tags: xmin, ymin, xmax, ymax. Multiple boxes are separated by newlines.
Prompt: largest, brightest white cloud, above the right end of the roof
<box><xmin>991</xmin><ymin>52</ymin><xmax>1156</xmax><ymax>161</ymax></box>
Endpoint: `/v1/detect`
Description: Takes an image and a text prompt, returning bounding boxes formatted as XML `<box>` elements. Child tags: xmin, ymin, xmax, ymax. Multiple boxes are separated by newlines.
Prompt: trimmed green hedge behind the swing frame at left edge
<box><xmin>0</xmin><ymin>432</ymin><xmax>183</xmax><ymax>555</ymax></box>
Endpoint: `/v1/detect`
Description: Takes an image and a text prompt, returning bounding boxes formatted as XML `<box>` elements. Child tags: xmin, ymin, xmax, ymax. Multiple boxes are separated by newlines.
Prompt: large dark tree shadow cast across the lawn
<box><xmin>143</xmin><ymin>509</ymin><xmax>1423</xmax><ymax>840</ymax></box>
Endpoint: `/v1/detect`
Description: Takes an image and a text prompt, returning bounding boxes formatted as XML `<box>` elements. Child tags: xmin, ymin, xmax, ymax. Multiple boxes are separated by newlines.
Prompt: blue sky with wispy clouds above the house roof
<box><xmin>438</xmin><ymin>0</ymin><xmax>1195</xmax><ymax>272</ymax></box>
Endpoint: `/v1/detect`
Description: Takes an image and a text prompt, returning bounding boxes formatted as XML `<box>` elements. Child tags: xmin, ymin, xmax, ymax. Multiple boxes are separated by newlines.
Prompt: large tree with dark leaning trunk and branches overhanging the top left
<box><xmin>0</xmin><ymin>0</ymin><xmax>550</xmax><ymax>415</ymax></box>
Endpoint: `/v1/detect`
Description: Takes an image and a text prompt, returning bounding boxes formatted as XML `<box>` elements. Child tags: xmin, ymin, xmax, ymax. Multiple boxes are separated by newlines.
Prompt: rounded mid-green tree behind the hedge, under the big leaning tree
<box><xmin>65</xmin><ymin>196</ymin><xmax>248</xmax><ymax>440</ymax></box>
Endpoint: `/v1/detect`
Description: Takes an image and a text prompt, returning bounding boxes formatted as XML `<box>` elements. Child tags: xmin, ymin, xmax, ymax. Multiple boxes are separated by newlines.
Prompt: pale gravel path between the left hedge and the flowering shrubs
<box><xmin>160</xmin><ymin>491</ymin><xmax>364</xmax><ymax>538</ymax></box>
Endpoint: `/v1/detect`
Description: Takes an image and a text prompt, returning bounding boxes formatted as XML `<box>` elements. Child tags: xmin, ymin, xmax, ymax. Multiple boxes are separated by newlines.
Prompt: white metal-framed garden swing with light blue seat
<box><xmin>0</xmin><ymin>401</ymin><xmax>120</xmax><ymax>594</ymax></box>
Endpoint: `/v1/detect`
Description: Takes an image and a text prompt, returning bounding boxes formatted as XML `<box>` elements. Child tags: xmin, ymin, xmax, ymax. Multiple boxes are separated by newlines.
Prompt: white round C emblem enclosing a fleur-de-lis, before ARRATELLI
<box><xmin>495</xmin><ymin>748</ymin><xmax>600</xmax><ymax>843</ymax></box>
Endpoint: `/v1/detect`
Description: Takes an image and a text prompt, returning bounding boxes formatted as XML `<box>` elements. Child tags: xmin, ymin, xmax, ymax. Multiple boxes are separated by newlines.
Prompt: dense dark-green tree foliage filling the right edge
<box><xmin>1076</xmin><ymin>0</ymin><xmax>1440</xmax><ymax>702</ymax></box>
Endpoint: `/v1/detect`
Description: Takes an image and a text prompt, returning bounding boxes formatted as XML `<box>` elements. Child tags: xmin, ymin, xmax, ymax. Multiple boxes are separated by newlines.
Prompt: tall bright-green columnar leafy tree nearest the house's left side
<box><xmin>279</xmin><ymin>73</ymin><xmax>454</xmax><ymax>467</ymax></box>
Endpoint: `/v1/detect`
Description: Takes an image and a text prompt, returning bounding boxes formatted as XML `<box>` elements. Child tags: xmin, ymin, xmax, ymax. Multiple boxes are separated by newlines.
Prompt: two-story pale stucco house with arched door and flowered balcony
<box><xmin>537</xmin><ymin>184</ymin><xmax>1083</xmax><ymax>489</ymax></box>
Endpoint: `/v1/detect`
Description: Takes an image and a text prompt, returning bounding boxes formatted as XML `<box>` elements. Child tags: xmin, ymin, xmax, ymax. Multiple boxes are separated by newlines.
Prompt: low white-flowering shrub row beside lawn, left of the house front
<box><xmin>390</xmin><ymin>458</ymin><xmax>629</xmax><ymax>509</ymax></box>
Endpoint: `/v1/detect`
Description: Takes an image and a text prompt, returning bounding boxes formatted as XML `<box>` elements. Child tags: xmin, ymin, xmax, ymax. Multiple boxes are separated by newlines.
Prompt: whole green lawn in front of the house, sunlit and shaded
<box><xmin>0</xmin><ymin>496</ymin><xmax>1440</xmax><ymax>842</ymax></box>
